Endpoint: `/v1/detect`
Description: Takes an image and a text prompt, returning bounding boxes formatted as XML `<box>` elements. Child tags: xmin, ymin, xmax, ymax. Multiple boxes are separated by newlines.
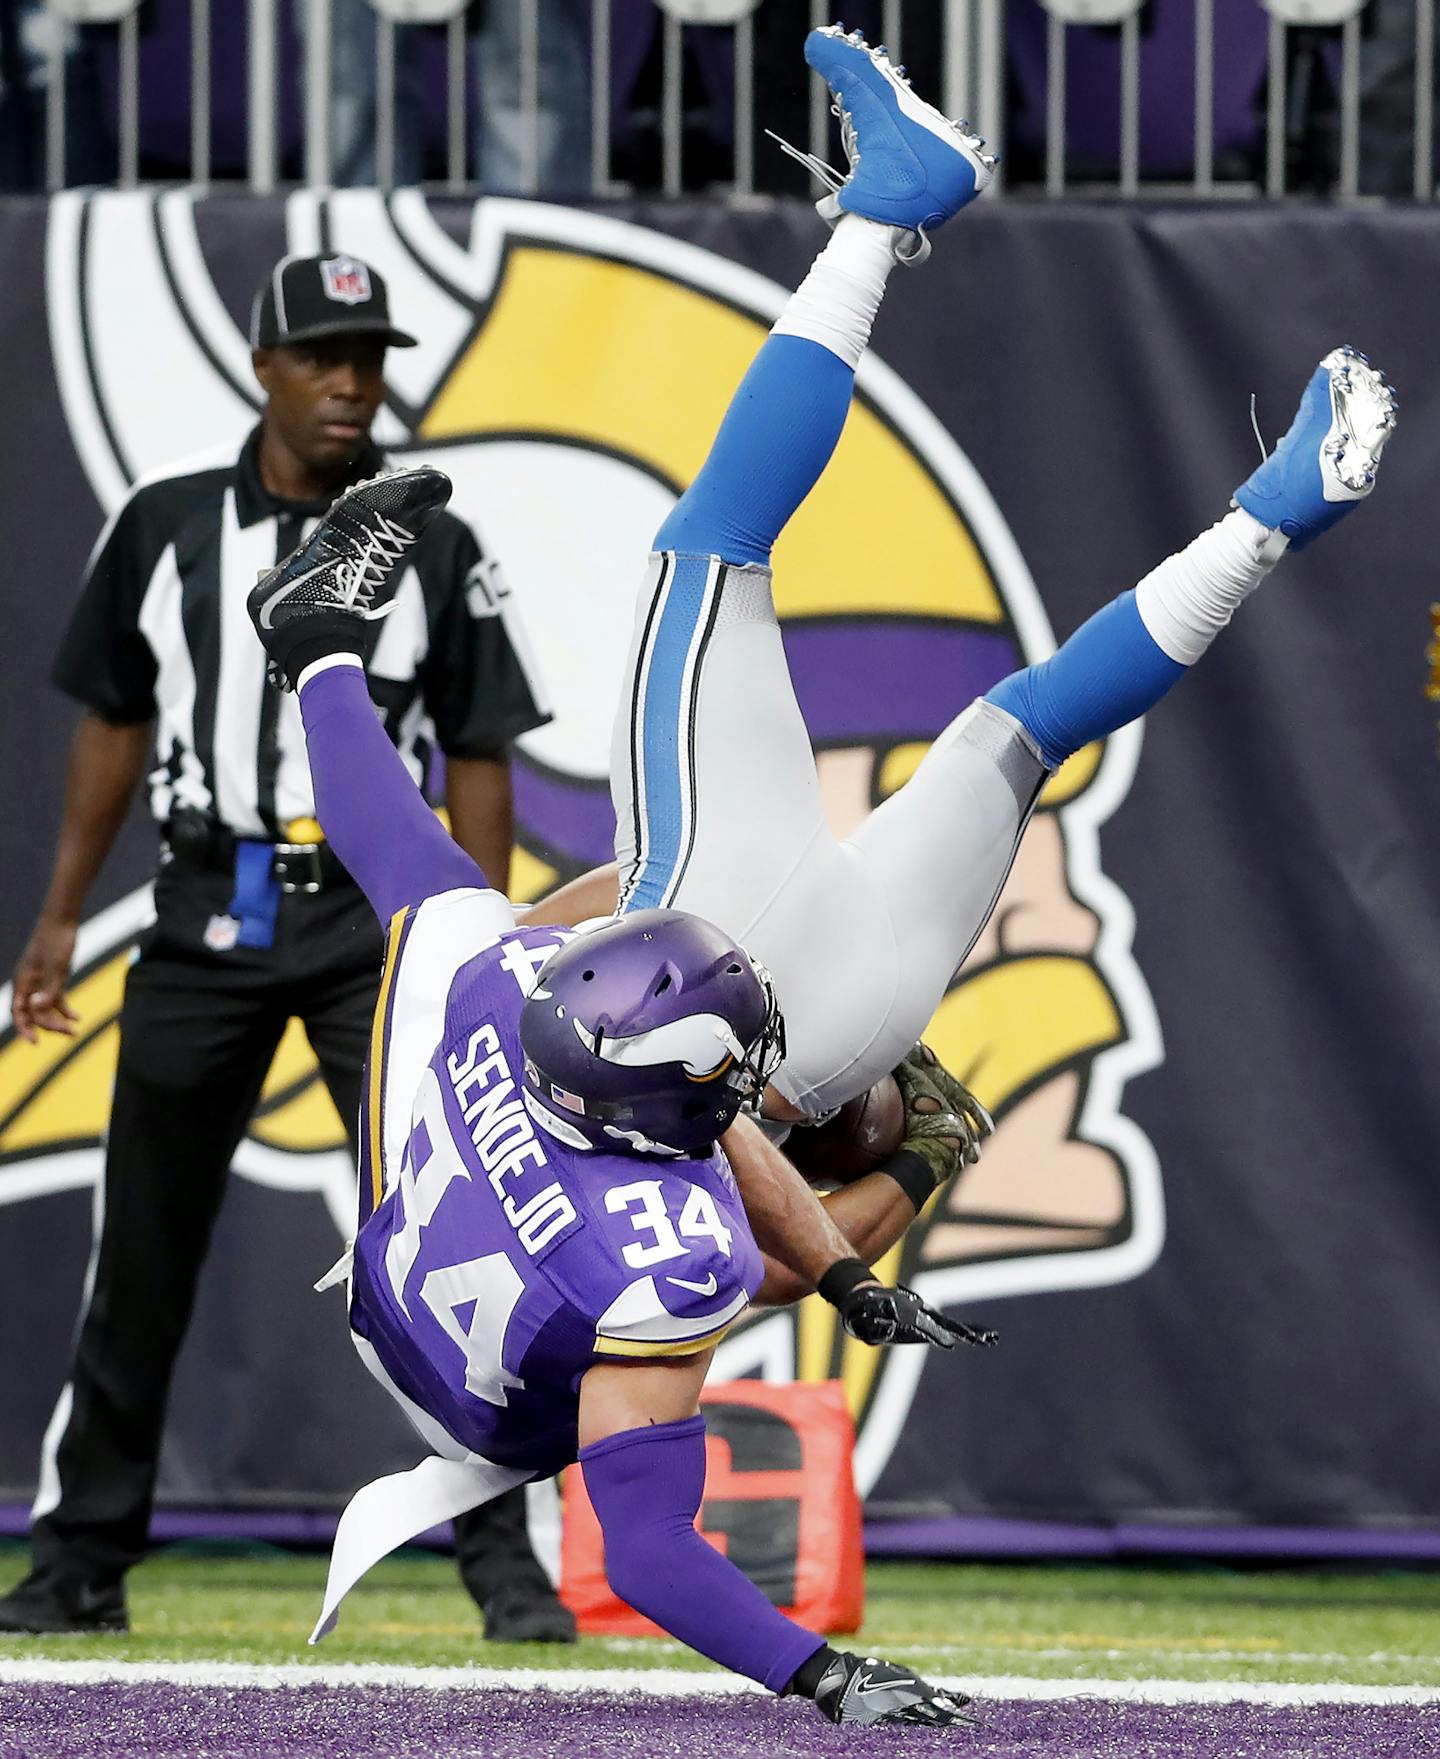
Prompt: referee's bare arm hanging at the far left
<box><xmin>11</xmin><ymin>711</ymin><xmax>149</xmax><ymax>1045</ymax></box>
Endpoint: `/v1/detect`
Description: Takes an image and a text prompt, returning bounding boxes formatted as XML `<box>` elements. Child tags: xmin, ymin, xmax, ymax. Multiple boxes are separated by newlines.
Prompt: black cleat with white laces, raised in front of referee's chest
<box><xmin>248</xmin><ymin>464</ymin><xmax>450</xmax><ymax>690</ymax></box>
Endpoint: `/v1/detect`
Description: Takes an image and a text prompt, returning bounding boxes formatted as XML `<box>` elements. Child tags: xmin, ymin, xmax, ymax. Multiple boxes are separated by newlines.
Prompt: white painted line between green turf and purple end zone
<box><xmin>0</xmin><ymin>1660</ymin><xmax>1440</xmax><ymax>1706</ymax></box>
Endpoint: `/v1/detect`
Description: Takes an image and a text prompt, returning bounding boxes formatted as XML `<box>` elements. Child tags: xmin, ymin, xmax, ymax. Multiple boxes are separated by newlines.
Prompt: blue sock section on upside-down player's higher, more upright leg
<box><xmin>656</xmin><ymin>336</ymin><xmax>855</xmax><ymax>565</ymax></box>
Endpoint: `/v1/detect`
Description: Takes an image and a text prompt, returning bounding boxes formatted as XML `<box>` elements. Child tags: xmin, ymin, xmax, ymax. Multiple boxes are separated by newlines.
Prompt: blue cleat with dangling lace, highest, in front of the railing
<box><xmin>774</xmin><ymin>25</ymin><xmax>995</xmax><ymax>262</ymax></box>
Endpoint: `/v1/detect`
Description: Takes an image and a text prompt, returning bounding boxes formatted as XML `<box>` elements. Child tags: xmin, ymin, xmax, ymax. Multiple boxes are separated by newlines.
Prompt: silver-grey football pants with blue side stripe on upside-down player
<box><xmin>610</xmin><ymin>552</ymin><xmax>1046</xmax><ymax>1119</ymax></box>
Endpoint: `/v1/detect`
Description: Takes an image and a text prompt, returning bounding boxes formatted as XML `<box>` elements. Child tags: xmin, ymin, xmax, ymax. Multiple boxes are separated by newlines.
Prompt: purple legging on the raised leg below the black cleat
<box><xmin>301</xmin><ymin>665</ymin><xmax>489</xmax><ymax>922</ymax></box>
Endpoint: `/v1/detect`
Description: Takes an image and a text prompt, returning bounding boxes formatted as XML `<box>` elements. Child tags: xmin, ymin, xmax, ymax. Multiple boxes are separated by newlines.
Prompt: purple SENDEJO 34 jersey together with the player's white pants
<box><xmin>350</xmin><ymin>892</ymin><xmax>761</xmax><ymax>1474</ymax></box>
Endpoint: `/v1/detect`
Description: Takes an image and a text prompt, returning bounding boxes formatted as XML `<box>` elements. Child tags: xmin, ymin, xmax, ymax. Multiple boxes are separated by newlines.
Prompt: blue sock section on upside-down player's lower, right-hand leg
<box><xmin>985</xmin><ymin>591</ymin><xmax>1189</xmax><ymax>769</ymax></box>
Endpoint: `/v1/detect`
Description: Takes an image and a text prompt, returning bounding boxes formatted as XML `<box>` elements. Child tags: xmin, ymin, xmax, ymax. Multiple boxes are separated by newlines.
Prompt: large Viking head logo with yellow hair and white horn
<box><xmin>0</xmin><ymin>193</ymin><xmax>1162</xmax><ymax>1512</ymax></box>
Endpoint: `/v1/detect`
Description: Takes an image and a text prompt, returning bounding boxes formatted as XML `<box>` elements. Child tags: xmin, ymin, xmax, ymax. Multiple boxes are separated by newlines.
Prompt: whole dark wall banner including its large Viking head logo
<box><xmin>11</xmin><ymin>190</ymin><xmax>1440</xmax><ymax>1548</ymax></box>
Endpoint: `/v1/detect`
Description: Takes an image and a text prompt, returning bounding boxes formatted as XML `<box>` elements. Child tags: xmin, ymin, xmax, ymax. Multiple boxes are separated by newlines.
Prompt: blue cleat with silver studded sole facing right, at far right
<box><xmin>1234</xmin><ymin>348</ymin><xmax>1398</xmax><ymax>549</ymax></box>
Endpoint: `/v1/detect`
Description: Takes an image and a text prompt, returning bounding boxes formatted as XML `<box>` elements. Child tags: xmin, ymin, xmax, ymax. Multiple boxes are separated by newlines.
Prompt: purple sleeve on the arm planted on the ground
<box><xmin>580</xmin><ymin>1416</ymin><xmax>825</xmax><ymax>1692</ymax></box>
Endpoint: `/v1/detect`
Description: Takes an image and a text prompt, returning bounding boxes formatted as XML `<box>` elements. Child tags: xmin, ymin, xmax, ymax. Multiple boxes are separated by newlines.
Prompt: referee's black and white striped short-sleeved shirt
<box><xmin>53</xmin><ymin>429</ymin><xmax>549</xmax><ymax>839</ymax></box>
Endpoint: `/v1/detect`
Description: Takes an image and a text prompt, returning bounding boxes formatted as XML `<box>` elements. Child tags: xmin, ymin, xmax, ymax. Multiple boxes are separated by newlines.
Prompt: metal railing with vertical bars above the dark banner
<box><xmin>30</xmin><ymin>0</ymin><xmax>1436</xmax><ymax>201</ymax></box>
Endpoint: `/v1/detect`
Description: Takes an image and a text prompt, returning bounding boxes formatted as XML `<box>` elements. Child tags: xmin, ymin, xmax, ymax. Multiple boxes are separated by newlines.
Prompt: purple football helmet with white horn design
<box><xmin>520</xmin><ymin>909</ymin><xmax>784</xmax><ymax>1156</ymax></box>
